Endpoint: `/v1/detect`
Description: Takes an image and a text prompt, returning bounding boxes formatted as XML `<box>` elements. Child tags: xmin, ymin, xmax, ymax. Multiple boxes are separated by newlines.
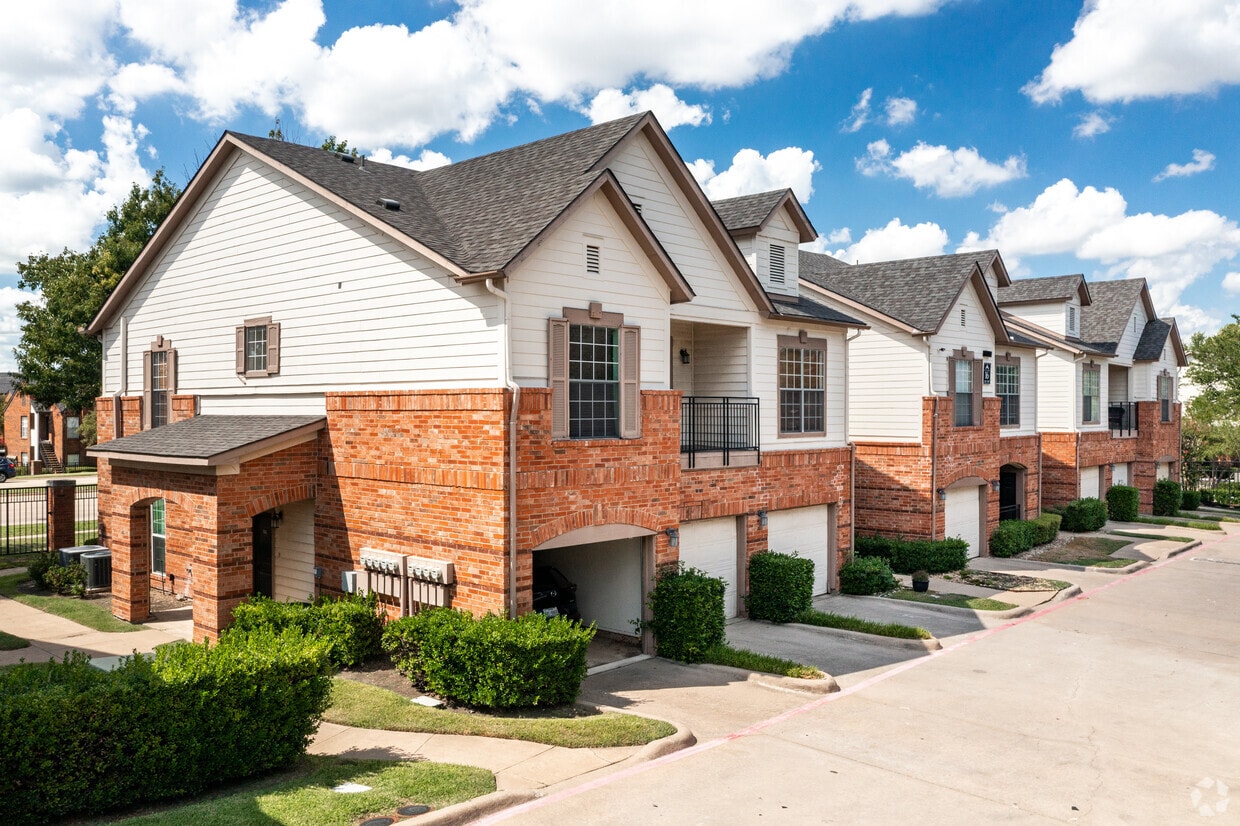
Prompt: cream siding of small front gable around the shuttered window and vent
<box><xmin>505</xmin><ymin>195</ymin><xmax>671</xmax><ymax>389</ymax></box>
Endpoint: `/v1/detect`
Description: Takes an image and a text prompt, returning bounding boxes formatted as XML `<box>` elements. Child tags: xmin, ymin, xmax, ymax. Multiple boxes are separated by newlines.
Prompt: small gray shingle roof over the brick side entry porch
<box><xmin>91</xmin><ymin>415</ymin><xmax>326</xmax><ymax>460</ymax></box>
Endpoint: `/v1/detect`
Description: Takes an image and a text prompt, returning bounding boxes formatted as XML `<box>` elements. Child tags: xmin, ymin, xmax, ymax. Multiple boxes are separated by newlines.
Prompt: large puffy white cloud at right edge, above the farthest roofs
<box><xmin>961</xmin><ymin>179</ymin><xmax>1240</xmax><ymax>308</ymax></box>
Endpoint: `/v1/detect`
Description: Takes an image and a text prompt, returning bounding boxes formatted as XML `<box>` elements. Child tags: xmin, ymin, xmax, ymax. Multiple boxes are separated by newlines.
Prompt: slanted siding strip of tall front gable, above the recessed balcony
<box><xmin>610</xmin><ymin>135</ymin><xmax>753</xmax><ymax>324</ymax></box>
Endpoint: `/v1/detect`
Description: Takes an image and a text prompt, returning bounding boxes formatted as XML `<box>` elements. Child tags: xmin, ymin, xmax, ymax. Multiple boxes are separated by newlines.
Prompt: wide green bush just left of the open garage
<box><xmin>383</xmin><ymin>606</ymin><xmax>592</xmax><ymax>708</ymax></box>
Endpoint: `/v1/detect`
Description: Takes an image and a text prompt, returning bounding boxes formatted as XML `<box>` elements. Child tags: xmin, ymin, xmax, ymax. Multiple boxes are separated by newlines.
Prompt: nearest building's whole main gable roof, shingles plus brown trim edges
<box><xmin>87</xmin><ymin>112</ymin><xmax>748</xmax><ymax>335</ymax></box>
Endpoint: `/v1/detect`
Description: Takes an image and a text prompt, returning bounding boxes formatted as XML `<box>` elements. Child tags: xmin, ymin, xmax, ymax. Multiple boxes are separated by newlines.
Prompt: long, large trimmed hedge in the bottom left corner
<box><xmin>0</xmin><ymin>630</ymin><xmax>331</xmax><ymax>824</ymax></box>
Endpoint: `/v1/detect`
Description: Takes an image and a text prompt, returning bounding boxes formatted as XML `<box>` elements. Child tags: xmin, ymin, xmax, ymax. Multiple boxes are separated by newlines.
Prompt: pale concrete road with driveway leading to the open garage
<box><xmin>485</xmin><ymin>533</ymin><xmax>1240</xmax><ymax>826</ymax></box>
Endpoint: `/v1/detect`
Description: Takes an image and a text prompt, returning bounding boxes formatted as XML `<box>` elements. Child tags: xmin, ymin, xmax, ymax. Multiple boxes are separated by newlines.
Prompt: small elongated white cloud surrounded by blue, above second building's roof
<box><xmin>857</xmin><ymin>140</ymin><xmax>1025</xmax><ymax>198</ymax></box>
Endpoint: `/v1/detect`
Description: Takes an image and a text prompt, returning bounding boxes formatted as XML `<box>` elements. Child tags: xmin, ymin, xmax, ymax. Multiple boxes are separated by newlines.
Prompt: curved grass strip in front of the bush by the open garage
<box><xmin>324</xmin><ymin>677</ymin><xmax>676</xmax><ymax>749</ymax></box>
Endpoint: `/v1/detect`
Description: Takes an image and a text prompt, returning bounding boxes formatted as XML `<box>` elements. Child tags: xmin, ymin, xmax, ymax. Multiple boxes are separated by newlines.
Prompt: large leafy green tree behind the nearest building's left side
<box><xmin>14</xmin><ymin>170</ymin><xmax>181</xmax><ymax>409</ymax></box>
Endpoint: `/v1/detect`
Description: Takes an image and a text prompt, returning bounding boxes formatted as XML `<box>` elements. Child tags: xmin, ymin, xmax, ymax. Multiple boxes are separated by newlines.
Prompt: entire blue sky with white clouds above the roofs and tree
<box><xmin>0</xmin><ymin>0</ymin><xmax>1240</xmax><ymax>370</ymax></box>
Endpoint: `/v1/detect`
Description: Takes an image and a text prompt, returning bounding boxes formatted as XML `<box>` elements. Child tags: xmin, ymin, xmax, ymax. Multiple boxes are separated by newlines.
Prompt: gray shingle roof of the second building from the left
<box><xmin>799</xmin><ymin>249</ymin><xmax>998</xmax><ymax>332</ymax></box>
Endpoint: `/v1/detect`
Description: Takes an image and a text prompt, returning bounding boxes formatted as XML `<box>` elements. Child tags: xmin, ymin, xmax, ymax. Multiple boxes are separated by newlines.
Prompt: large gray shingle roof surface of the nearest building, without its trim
<box><xmin>229</xmin><ymin>114</ymin><xmax>645</xmax><ymax>273</ymax></box>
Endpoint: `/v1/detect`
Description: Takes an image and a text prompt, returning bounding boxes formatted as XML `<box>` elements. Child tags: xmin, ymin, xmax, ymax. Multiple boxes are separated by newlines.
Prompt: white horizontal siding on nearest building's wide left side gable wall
<box><xmin>104</xmin><ymin>155</ymin><xmax>501</xmax><ymax>412</ymax></box>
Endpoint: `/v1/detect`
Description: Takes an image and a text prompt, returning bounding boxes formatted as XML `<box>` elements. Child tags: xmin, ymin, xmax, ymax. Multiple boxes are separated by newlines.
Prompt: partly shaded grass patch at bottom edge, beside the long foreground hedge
<box><xmin>108</xmin><ymin>757</ymin><xmax>495</xmax><ymax>826</ymax></box>
